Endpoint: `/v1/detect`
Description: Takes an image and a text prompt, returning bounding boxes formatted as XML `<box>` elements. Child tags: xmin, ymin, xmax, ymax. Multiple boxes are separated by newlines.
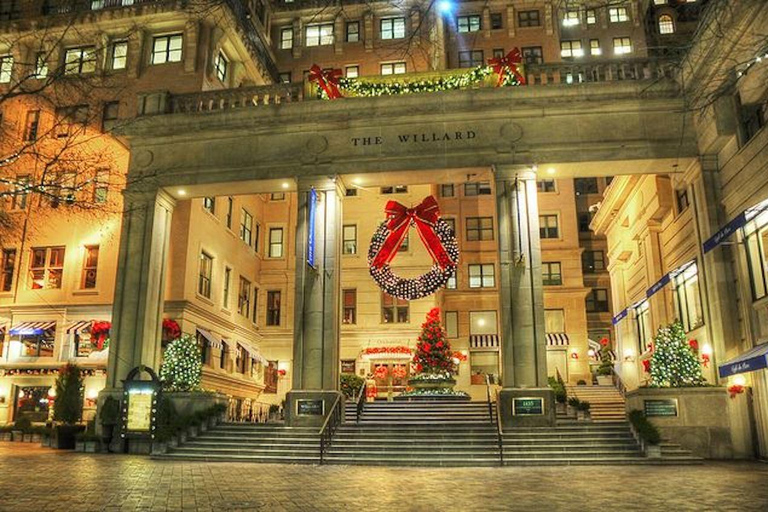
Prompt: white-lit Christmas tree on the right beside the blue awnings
<box><xmin>650</xmin><ymin>322</ymin><xmax>704</xmax><ymax>388</ymax></box>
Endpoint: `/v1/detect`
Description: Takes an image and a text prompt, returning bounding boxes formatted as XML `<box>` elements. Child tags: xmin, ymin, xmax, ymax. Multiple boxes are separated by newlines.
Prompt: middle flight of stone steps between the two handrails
<box><xmin>325</xmin><ymin>402</ymin><xmax>499</xmax><ymax>466</ymax></box>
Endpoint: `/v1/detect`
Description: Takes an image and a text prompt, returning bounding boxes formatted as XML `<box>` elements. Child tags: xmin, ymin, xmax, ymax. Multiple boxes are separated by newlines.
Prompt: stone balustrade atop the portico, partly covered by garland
<box><xmin>154</xmin><ymin>59</ymin><xmax>676</xmax><ymax>113</ymax></box>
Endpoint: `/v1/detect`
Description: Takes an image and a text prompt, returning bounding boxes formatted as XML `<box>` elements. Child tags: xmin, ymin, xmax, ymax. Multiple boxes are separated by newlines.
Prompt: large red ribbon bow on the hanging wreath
<box><xmin>371</xmin><ymin>196</ymin><xmax>454</xmax><ymax>268</ymax></box>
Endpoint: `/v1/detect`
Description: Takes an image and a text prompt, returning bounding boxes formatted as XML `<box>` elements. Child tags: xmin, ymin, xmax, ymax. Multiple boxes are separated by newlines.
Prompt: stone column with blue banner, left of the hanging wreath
<box><xmin>286</xmin><ymin>178</ymin><xmax>343</xmax><ymax>426</ymax></box>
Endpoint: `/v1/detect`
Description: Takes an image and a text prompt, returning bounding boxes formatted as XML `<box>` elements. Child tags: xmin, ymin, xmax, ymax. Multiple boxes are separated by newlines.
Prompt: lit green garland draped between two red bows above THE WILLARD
<box><xmin>317</xmin><ymin>66</ymin><xmax>520</xmax><ymax>99</ymax></box>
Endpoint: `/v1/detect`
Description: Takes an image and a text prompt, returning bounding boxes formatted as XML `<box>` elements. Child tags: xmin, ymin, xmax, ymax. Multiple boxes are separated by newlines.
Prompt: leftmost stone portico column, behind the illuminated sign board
<box><xmin>107</xmin><ymin>190</ymin><xmax>175</xmax><ymax>389</ymax></box>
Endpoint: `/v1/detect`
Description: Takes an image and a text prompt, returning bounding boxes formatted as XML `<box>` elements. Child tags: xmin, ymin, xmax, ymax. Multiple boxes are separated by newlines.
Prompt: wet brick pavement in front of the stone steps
<box><xmin>0</xmin><ymin>442</ymin><xmax>768</xmax><ymax>512</ymax></box>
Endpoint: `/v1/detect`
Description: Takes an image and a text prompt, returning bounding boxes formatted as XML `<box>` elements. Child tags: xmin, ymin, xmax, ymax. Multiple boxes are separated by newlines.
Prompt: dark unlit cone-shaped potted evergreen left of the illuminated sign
<box><xmin>51</xmin><ymin>363</ymin><xmax>85</xmax><ymax>450</ymax></box>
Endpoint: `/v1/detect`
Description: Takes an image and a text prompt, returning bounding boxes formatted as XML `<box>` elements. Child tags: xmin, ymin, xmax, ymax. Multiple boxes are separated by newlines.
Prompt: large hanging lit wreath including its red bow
<box><xmin>368</xmin><ymin>196</ymin><xmax>459</xmax><ymax>300</ymax></box>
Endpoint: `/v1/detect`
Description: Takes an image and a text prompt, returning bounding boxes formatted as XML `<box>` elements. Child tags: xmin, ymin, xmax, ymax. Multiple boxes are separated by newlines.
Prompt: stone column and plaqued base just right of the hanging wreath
<box><xmin>495</xmin><ymin>167</ymin><xmax>555</xmax><ymax>427</ymax></box>
